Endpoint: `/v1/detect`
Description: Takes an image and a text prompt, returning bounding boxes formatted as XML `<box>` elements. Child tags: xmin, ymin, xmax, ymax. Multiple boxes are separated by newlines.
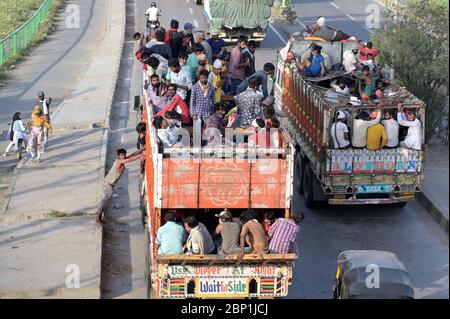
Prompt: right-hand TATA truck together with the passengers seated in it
<box><xmin>275</xmin><ymin>35</ymin><xmax>425</xmax><ymax>207</ymax></box>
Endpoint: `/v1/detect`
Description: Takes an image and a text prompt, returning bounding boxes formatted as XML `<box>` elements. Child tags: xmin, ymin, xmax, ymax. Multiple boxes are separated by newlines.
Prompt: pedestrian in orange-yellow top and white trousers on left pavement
<box><xmin>25</xmin><ymin>105</ymin><xmax>52</xmax><ymax>162</ymax></box>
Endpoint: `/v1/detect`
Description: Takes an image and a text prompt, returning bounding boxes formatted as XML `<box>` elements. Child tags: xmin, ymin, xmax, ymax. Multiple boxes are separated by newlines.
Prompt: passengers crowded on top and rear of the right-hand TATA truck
<box><xmin>284</xmin><ymin>17</ymin><xmax>423</xmax><ymax>150</ymax></box>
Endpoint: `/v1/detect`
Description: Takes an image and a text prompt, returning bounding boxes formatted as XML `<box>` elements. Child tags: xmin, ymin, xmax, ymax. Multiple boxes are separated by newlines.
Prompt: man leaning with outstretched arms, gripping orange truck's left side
<box><xmin>96</xmin><ymin>148</ymin><xmax>144</xmax><ymax>224</ymax></box>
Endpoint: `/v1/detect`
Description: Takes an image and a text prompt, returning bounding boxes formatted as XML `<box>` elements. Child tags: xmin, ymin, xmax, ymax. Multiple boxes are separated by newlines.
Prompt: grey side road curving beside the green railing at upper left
<box><xmin>0</xmin><ymin>0</ymin><xmax>107</xmax><ymax>172</ymax></box>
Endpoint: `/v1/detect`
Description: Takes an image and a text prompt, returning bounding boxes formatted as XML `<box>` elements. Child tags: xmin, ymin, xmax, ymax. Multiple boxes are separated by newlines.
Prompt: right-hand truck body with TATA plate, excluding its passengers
<box><xmin>275</xmin><ymin>37</ymin><xmax>425</xmax><ymax>207</ymax></box>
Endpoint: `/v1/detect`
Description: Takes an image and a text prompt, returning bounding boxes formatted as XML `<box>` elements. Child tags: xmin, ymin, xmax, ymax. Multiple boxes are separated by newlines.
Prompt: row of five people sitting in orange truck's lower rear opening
<box><xmin>156</xmin><ymin>210</ymin><xmax>304</xmax><ymax>257</ymax></box>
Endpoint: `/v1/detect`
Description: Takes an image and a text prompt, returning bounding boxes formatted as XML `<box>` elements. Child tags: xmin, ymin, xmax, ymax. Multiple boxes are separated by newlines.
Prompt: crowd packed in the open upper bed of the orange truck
<box><xmin>134</xmin><ymin>20</ymin><xmax>281</xmax><ymax>148</ymax></box>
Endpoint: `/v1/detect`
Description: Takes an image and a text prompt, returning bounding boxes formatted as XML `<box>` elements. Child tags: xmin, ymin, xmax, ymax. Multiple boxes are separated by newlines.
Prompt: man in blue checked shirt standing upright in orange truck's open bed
<box><xmin>189</xmin><ymin>70</ymin><xmax>216</xmax><ymax>126</ymax></box>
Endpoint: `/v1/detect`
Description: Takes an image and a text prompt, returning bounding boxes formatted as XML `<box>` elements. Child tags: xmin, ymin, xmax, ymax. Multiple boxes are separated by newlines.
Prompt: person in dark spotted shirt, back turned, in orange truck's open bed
<box><xmin>233</xmin><ymin>77</ymin><xmax>261</xmax><ymax>128</ymax></box>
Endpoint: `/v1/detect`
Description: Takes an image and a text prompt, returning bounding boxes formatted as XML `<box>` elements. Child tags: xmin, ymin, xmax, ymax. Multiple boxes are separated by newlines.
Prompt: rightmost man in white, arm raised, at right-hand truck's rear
<box><xmin>397</xmin><ymin>103</ymin><xmax>422</xmax><ymax>151</ymax></box>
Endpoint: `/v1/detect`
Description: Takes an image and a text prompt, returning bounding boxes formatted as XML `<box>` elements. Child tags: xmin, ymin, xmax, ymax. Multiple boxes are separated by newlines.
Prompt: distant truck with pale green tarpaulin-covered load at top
<box><xmin>203</xmin><ymin>0</ymin><xmax>273</xmax><ymax>44</ymax></box>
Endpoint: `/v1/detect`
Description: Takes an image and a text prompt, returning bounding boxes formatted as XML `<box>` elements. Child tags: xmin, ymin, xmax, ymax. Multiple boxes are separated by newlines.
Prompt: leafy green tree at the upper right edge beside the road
<box><xmin>373</xmin><ymin>0</ymin><xmax>449</xmax><ymax>139</ymax></box>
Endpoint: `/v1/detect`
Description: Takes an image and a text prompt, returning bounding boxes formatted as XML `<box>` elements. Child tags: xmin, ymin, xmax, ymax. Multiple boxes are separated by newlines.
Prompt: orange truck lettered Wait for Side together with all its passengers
<box><xmin>134</xmin><ymin>15</ymin><xmax>303</xmax><ymax>298</ymax></box>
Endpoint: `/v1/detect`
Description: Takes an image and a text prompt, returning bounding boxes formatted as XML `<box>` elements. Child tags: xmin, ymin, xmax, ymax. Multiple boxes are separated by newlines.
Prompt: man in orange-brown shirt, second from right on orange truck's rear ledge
<box><xmin>239</xmin><ymin>210</ymin><xmax>269</xmax><ymax>259</ymax></box>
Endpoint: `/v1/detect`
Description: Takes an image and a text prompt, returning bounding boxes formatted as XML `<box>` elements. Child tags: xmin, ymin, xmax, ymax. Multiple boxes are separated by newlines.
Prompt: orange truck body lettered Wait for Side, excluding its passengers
<box><xmin>141</xmin><ymin>87</ymin><xmax>297</xmax><ymax>298</ymax></box>
